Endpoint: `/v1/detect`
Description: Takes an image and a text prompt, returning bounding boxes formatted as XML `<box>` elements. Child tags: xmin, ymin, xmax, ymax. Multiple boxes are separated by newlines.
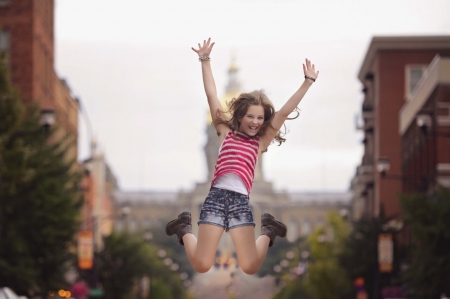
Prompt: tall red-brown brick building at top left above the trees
<box><xmin>0</xmin><ymin>0</ymin><xmax>78</xmax><ymax>164</ymax></box>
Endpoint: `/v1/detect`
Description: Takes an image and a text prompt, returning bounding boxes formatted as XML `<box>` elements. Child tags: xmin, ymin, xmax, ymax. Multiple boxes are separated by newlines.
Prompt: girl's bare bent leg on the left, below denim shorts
<box><xmin>183</xmin><ymin>224</ymin><xmax>224</xmax><ymax>273</ymax></box>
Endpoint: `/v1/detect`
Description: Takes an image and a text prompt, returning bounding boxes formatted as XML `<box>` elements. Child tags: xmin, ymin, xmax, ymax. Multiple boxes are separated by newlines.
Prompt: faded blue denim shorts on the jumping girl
<box><xmin>197</xmin><ymin>187</ymin><xmax>255</xmax><ymax>231</ymax></box>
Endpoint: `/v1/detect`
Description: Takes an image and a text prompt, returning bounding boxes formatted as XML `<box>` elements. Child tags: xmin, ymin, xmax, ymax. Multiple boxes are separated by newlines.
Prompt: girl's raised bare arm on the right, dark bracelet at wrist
<box><xmin>261</xmin><ymin>59</ymin><xmax>319</xmax><ymax>151</ymax></box>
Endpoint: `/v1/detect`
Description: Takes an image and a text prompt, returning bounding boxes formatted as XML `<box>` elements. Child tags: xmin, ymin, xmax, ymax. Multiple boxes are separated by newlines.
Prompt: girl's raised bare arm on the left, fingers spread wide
<box><xmin>192</xmin><ymin>38</ymin><xmax>229</xmax><ymax>137</ymax></box>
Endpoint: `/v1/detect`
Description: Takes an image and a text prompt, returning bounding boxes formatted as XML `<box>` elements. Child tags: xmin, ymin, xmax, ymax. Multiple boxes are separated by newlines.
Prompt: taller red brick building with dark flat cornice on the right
<box><xmin>351</xmin><ymin>36</ymin><xmax>450</xmax><ymax>220</ymax></box>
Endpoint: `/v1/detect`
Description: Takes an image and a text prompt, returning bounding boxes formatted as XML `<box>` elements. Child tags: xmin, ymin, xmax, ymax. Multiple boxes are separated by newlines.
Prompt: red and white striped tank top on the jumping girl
<box><xmin>211</xmin><ymin>131</ymin><xmax>259</xmax><ymax>195</ymax></box>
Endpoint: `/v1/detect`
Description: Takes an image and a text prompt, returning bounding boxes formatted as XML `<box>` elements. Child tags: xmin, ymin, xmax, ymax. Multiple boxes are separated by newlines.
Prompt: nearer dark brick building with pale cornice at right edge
<box><xmin>399</xmin><ymin>55</ymin><xmax>450</xmax><ymax>195</ymax></box>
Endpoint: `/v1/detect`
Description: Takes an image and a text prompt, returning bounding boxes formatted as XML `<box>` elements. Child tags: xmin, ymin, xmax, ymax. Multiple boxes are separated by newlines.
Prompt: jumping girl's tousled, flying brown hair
<box><xmin>213</xmin><ymin>90</ymin><xmax>299</xmax><ymax>149</ymax></box>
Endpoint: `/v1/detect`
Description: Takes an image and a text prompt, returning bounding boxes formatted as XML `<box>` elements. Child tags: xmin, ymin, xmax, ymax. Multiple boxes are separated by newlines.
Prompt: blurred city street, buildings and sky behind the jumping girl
<box><xmin>0</xmin><ymin>0</ymin><xmax>450</xmax><ymax>299</ymax></box>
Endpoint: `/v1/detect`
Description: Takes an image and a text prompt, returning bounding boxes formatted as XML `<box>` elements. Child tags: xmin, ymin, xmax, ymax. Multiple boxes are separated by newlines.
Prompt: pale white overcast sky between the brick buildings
<box><xmin>55</xmin><ymin>0</ymin><xmax>450</xmax><ymax>192</ymax></box>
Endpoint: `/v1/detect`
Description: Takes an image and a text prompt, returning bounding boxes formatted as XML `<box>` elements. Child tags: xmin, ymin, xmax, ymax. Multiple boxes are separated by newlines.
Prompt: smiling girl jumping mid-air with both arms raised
<box><xmin>166</xmin><ymin>39</ymin><xmax>319</xmax><ymax>274</ymax></box>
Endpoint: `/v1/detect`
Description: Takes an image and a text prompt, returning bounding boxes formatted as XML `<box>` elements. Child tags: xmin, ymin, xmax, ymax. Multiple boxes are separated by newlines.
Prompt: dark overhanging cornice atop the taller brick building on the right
<box><xmin>358</xmin><ymin>35</ymin><xmax>450</xmax><ymax>82</ymax></box>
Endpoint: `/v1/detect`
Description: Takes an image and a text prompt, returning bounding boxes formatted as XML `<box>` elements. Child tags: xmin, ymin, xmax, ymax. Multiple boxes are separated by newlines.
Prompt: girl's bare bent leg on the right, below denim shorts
<box><xmin>229</xmin><ymin>226</ymin><xmax>270</xmax><ymax>274</ymax></box>
